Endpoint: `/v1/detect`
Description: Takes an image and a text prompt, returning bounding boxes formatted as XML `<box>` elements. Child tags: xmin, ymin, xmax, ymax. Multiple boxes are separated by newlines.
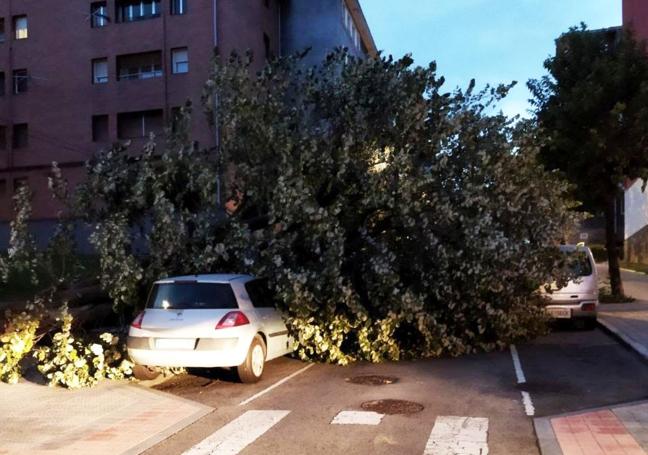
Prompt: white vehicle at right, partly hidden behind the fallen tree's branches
<box><xmin>545</xmin><ymin>244</ymin><xmax>599</xmax><ymax>328</ymax></box>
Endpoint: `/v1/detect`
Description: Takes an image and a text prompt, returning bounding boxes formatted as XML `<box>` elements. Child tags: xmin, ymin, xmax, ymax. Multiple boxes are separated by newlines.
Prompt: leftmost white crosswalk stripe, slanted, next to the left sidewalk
<box><xmin>184</xmin><ymin>411</ymin><xmax>290</xmax><ymax>455</ymax></box>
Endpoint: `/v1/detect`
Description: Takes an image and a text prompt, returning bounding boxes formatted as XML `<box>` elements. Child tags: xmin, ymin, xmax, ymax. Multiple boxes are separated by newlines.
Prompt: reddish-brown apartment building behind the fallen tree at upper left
<box><xmin>0</xmin><ymin>0</ymin><xmax>376</xmax><ymax>242</ymax></box>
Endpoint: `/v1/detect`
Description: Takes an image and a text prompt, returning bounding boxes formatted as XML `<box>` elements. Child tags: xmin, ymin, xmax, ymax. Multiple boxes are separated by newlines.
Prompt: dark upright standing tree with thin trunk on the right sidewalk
<box><xmin>529</xmin><ymin>25</ymin><xmax>648</xmax><ymax>294</ymax></box>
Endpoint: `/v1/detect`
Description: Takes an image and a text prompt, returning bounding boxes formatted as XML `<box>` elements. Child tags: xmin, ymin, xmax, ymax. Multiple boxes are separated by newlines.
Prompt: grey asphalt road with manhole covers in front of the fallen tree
<box><xmin>146</xmin><ymin>330</ymin><xmax>648</xmax><ymax>455</ymax></box>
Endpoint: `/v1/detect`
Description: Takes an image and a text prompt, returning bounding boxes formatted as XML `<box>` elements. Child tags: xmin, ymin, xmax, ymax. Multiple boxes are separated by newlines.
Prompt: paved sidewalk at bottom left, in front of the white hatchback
<box><xmin>0</xmin><ymin>381</ymin><xmax>212</xmax><ymax>455</ymax></box>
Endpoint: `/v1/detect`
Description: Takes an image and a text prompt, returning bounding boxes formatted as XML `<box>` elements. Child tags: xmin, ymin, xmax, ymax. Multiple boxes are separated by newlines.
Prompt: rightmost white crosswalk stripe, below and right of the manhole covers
<box><xmin>423</xmin><ymin>416</ymin><xmax>488</xmax><ymax>455</ymax></box>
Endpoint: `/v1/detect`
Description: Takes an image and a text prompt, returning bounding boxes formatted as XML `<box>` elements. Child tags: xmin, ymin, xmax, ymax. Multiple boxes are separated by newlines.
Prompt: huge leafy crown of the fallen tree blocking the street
<box><xmin>2</xmin><ymin>51</ymin><xmax>574</xmax><ymax>371</ymax></box>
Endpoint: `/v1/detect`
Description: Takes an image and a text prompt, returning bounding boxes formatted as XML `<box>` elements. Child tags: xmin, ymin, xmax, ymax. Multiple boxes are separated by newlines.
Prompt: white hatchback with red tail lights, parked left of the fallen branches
<box><xmin>127</xmin><ymin>275</ymin><xmax>293</xmax><ymax>383</ymax></box>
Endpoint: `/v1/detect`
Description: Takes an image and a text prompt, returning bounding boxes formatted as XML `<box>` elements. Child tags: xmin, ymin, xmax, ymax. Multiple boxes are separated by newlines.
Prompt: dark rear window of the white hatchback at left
<box><xmin>146</xmin><ymin>281</ymin><xmax>238</xmax><ymax>310</ymax></box>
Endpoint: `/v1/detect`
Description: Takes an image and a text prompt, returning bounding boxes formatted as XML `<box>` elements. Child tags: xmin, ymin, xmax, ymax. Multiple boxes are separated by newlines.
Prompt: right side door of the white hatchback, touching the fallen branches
<box><xmin>245</xmin><ymin>279</ymin><xmax>290</xmax><ymax>359</ymax></box>
